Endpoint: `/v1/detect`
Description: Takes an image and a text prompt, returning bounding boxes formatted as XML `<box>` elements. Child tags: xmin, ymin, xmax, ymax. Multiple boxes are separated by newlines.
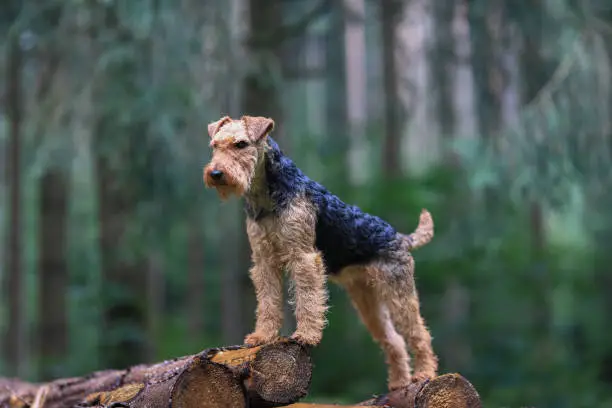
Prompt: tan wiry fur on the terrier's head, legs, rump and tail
<box><xmin>204</xmin><ymin>116</ymin><xmax>438</xmax><ymax>390</ymax></box>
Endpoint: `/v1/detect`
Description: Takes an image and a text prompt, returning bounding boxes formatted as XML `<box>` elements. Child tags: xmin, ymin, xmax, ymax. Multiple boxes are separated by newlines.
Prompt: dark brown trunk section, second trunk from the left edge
<box><xmin>37</xmin><ymin>169</ymin><xmax>69</xmax><ymax>379</ymax></box>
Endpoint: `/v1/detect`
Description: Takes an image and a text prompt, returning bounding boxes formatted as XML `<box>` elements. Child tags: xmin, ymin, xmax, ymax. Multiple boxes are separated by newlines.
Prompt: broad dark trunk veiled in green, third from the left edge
<box><xmin>94</xmin><ymin>3</ymin><xmax>153</xmax><ymax>368</ymax></box>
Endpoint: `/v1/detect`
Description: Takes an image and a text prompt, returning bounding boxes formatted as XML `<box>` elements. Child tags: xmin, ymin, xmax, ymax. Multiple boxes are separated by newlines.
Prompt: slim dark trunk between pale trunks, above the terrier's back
<box><xmin>380</xmin><ymin>0</ymin><xmax>404</xmax><ymax>179</ymax></box>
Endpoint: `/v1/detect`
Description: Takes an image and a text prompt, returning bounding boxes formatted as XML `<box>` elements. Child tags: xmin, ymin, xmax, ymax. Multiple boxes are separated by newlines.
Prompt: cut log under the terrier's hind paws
<box><xmin>286</xmin><ymin>373</ymin><xmax>482</xmax><ymax>408</ymax></box>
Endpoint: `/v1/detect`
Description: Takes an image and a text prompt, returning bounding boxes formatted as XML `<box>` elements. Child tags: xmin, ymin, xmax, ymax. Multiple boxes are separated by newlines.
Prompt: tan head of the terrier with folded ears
<box><xmin>204</xmin><ymin>116</ymin><xmax>274</xmax><ymax>199</ymax></box>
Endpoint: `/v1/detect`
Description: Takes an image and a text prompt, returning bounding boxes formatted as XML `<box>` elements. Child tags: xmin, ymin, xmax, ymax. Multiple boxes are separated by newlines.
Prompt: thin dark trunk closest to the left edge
<box><xmin>3</xmin><ymin>30</ymin><xmax>26</xmax><ymax>374</ymax></box>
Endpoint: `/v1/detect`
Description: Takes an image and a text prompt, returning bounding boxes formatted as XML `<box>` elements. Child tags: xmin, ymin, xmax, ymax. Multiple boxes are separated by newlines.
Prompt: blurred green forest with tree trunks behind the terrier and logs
<box><xmin>0</xmin><ymin>0</ymin><xmax>612</xmax><ymax>408</ymax></box>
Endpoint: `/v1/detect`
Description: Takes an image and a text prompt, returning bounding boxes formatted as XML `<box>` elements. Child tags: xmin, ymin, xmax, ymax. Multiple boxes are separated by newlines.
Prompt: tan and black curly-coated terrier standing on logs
<box><xmin>204</xmin><ymin>116</ymin><xmax>438</xmax><ymax>390</ymax></box>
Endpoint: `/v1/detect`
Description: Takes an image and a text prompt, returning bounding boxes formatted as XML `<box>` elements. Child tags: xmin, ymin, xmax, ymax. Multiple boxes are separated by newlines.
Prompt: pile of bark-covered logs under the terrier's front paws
<box><xmin>0</xmin><ymin>339</ymin><xmax>312</xmax><ymax>408</ymax></box>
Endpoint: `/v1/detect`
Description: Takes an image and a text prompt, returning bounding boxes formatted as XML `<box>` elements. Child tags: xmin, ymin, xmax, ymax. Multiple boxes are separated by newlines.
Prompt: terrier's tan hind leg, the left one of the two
<box><xmin>339</xmin><ymin>269</ymin><xmax>411</xmax><ymax>390</ymax></box>
